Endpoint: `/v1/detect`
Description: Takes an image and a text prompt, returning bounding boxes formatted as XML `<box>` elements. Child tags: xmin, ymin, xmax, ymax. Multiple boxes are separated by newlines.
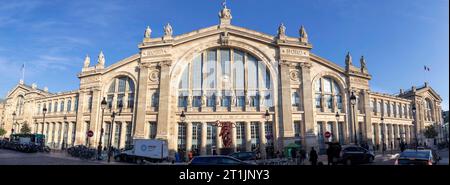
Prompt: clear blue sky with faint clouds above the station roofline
<box><xmin>0</xmin><ymin>0</ymin><xmax>449</xmax><ymax>110</ymax></box>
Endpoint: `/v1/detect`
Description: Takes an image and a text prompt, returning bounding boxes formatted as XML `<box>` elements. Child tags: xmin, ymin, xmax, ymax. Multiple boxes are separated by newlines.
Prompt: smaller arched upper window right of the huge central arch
<box><xmin>314</xmin><ymin>77</ymin><xmax>343</xmax><ymax>112</ymax></box>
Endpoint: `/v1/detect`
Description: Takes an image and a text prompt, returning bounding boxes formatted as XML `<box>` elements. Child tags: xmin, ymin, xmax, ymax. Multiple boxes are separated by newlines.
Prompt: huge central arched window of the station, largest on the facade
<box><xmin>178</xmin><ymin>48</ymin><xmax>273</xmax><ymax>110</ymax></box>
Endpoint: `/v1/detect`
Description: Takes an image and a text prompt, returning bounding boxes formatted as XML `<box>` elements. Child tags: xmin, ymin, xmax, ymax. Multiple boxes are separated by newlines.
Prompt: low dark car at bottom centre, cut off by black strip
<box><xmin>189</xmin><ymin>155</ymin><xmax>252</xmax><ymax>165</ymax></box>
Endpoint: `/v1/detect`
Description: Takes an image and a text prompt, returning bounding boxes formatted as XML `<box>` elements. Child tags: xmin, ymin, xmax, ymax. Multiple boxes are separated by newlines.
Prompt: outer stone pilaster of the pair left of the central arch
<box><xmin>133</xmin><ymin>65</ymin><xmax>149</xmax><ymax>138</ymax></box>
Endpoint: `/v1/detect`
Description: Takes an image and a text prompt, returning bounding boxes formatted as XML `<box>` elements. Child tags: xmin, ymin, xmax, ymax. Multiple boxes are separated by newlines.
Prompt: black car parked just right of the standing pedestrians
<box><xmin>340</xmin><ymin>146</ymin><xmax>375</xmax><ymax>165</ymax></box>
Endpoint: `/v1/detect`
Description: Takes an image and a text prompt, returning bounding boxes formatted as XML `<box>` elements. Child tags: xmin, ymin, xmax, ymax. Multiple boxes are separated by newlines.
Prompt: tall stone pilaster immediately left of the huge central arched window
<box><xmin>157</xmin><ymin>61</ymin><xmax>172</xmax><ymax>142</ymax></box>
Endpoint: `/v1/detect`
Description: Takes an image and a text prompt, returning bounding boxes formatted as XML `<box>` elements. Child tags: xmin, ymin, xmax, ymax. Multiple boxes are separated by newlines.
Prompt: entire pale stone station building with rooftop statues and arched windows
<box><xmin>2</xmin><ymin>7</ymin><xmax>442</xmax><ymax>156</ymax></box>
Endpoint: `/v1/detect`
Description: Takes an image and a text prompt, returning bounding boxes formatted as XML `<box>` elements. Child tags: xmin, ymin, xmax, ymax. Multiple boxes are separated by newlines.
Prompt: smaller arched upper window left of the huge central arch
<box><xmin>106</xmin><ymin>76</ymin><xmax>135</xmax><ymax>110</ymax></box>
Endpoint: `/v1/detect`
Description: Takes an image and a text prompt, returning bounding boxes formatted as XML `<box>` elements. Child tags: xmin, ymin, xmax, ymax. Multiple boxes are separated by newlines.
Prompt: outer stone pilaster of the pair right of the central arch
<box><xmin>298</xmin><ymin>62</ymin><xmax>319</xmax><ymax>148</ymax></box>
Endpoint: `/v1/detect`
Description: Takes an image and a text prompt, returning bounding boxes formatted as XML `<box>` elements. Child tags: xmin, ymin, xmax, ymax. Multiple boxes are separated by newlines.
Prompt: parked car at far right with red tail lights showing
<box><xmin>395</xmin><ymin>149</ymin><xmax>437</xmax><ymax>165</ymax></box>
